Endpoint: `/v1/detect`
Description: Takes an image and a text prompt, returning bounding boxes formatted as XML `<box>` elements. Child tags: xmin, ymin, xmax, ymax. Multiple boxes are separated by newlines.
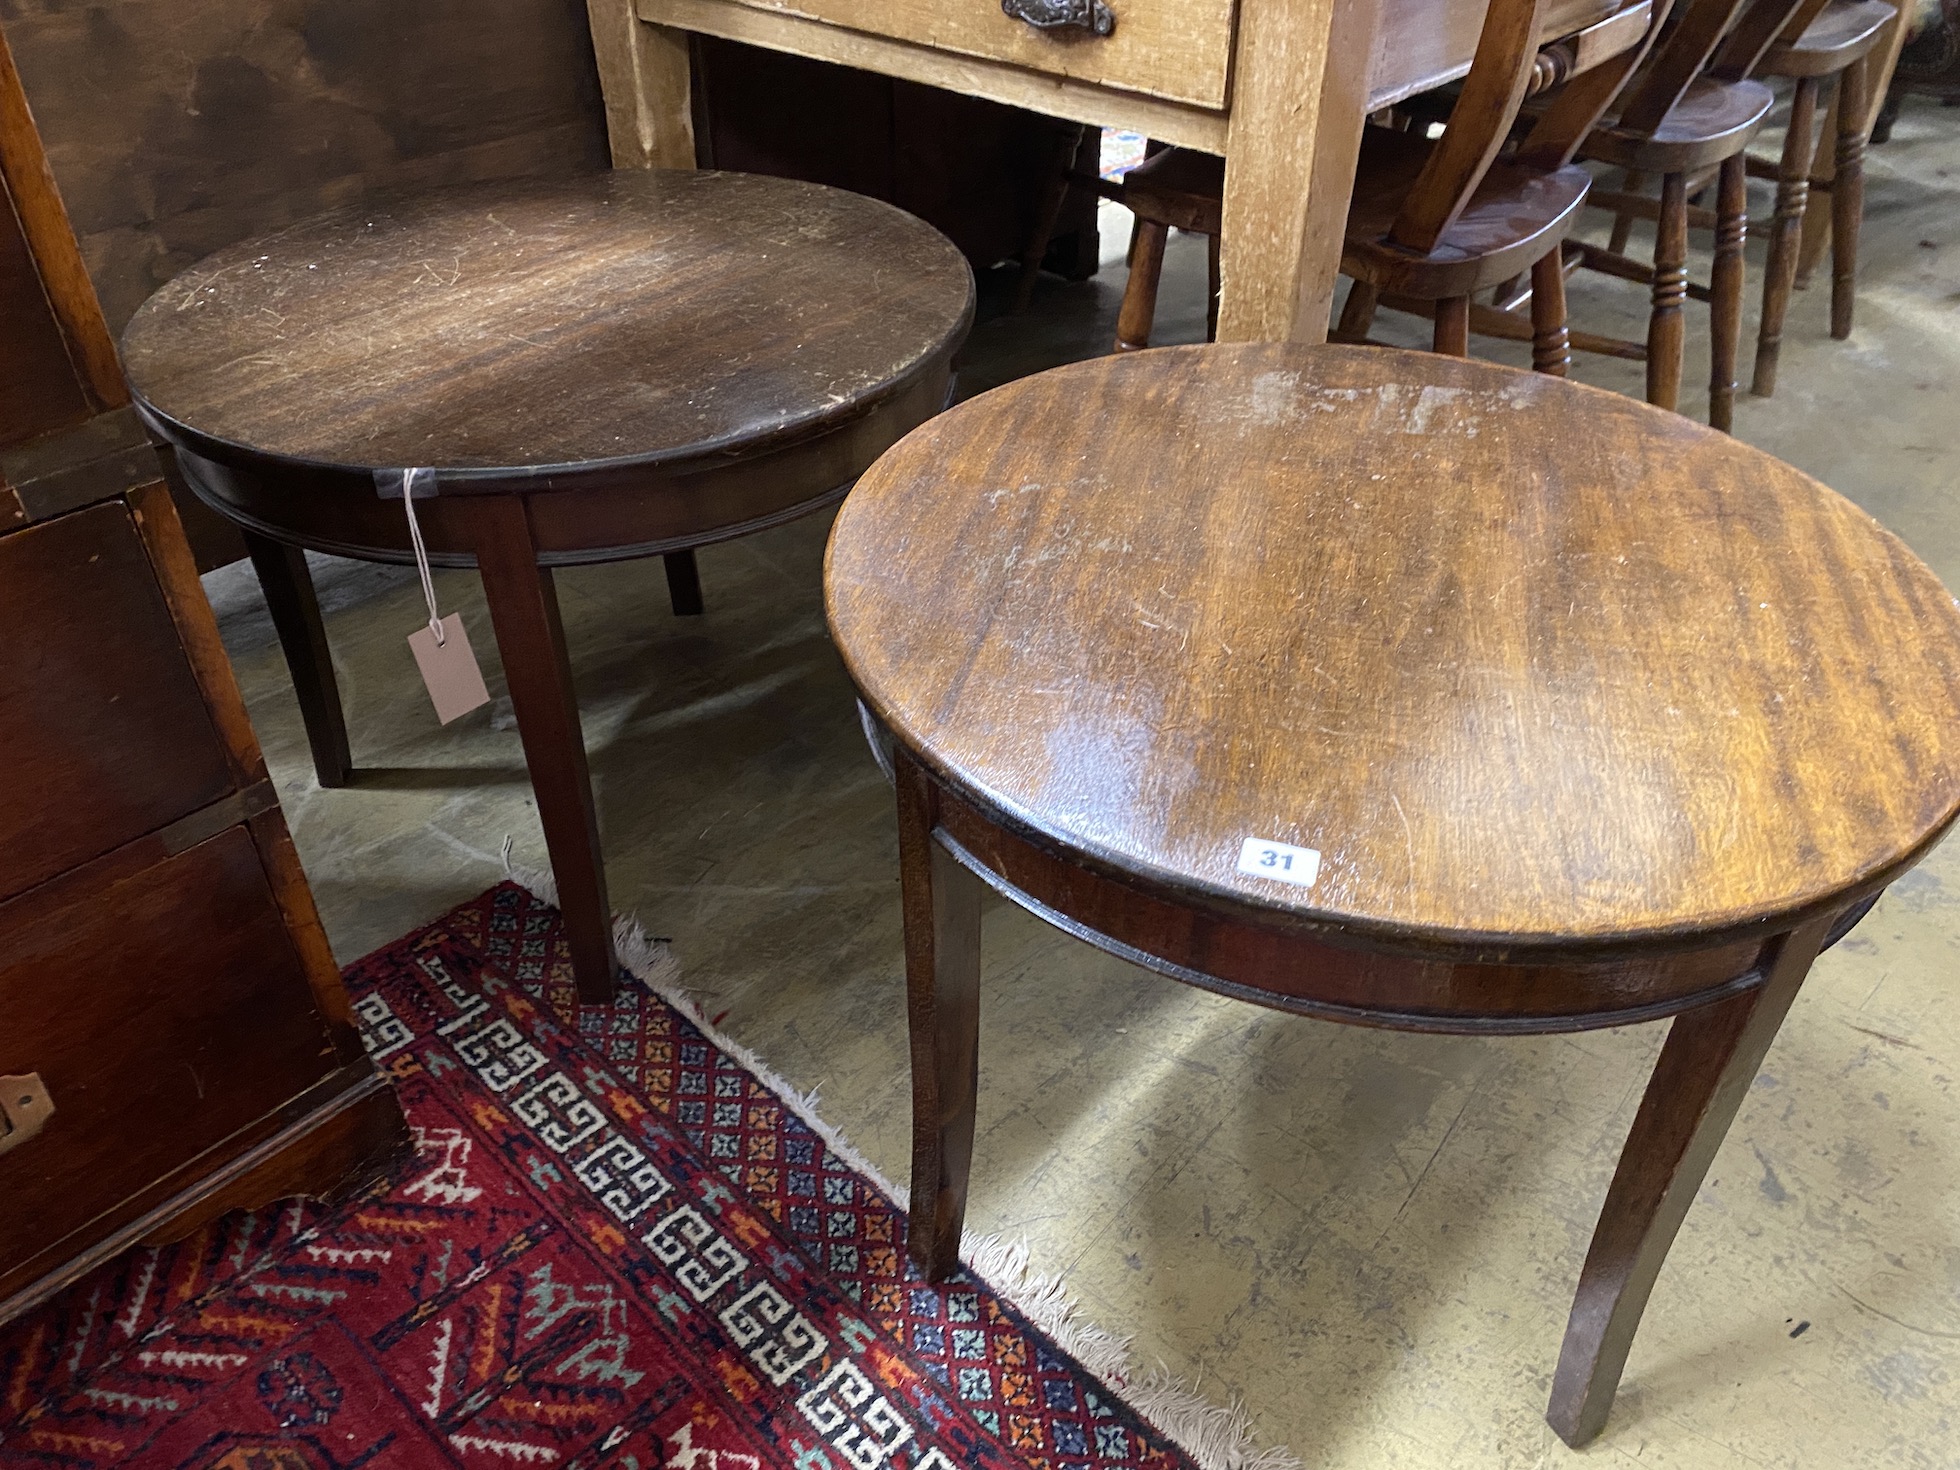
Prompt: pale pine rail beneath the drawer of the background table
<box><xmin>635</xmin><ymin>0</ymin><xmax>1225</xmax><ymax>153</ymax></box>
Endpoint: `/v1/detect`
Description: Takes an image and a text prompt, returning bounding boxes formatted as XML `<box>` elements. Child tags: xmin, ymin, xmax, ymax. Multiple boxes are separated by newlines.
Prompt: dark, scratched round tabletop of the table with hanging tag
<box><xmin>123</xmin><ymin>171</ymin><xmax>972</xmax><ymax>484</ymax></box>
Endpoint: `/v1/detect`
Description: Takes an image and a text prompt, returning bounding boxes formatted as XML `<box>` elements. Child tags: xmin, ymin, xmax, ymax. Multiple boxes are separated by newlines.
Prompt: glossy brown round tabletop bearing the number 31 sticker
<box><xmin>827</xmin><ymin>345</ymin><xmax>1960</xmax><ymax>958</ymax></box>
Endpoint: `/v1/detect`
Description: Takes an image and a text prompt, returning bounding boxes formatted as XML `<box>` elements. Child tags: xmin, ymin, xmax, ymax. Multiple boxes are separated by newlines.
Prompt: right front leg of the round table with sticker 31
<box><xmin>1544</xmin><ymin>919</ymin><xmax>1831</xmax><ymax>1446</ymax></box>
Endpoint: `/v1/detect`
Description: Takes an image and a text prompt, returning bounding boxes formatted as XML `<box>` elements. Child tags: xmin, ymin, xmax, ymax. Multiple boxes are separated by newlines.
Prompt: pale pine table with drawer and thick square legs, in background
<box><xmin>588</xmin><ymin>0</ymin><xmax>1613</xmax><ymax>341</ymax></box>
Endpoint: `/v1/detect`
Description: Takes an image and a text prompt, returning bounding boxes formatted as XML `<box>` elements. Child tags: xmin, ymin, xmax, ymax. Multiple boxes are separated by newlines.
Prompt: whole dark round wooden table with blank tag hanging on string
<box><xmin>123</xmin><ymin>171</ymin><xmax>974</xmax><ymax>1002</ymax></box>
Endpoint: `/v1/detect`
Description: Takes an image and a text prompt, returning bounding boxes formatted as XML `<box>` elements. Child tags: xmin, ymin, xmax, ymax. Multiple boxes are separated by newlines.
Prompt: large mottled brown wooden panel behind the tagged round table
<box><xmin>0</xmin><ymin>0</ymin><xmax>608</xmax><ymax>329</ymax></box>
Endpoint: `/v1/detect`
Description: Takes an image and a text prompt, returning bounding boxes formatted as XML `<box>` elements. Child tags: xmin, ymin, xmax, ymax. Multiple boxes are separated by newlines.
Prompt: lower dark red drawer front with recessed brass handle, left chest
<box><xmin>0</xmin><ymin>827</ymin><xmax>339</xmax><ymax>1298</ymax></box>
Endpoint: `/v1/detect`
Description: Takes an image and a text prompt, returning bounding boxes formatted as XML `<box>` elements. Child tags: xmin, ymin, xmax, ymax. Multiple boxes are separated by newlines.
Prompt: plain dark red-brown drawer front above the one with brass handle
<box><xmin>0</xmin><ymin>504</ymin><xmax>231</xmax><ymax>905</ymax></box>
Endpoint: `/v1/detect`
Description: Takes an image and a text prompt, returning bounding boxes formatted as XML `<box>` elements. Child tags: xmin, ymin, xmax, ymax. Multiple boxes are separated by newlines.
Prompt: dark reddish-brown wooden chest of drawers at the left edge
<box><xmin>0</xmin><ymin>28</ymin><xmax>404</xmax><ymax>1319</ymax></box>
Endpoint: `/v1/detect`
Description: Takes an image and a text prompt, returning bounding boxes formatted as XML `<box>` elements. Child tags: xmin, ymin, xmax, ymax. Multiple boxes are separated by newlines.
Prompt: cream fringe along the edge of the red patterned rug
<box><xmin>504</xmin><ymin>870</ymin><xmax>1301</xmax><ymax>1470</ymax></box>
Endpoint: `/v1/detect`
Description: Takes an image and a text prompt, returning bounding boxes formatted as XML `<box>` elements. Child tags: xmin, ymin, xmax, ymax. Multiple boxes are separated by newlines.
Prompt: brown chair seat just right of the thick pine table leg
<box><xmin>1341</xmin><ymin>127</ymin><xmax>1592</xmax><ymax>300</ymax></box>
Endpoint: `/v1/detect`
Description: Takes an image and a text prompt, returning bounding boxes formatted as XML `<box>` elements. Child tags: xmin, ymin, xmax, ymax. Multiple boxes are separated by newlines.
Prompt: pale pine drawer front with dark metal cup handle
<box><xmin>697</xmin><ymin>0</ymin><xmax>1237</xmax><ymax>108</ymax></box>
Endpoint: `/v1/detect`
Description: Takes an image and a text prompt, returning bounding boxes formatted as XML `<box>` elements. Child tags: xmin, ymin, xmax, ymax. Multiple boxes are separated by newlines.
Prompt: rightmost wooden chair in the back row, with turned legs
<box><xmin>1748</xmin><ymin>0</ymin><xmax>1899</xmax><ymax>398</ymax></box>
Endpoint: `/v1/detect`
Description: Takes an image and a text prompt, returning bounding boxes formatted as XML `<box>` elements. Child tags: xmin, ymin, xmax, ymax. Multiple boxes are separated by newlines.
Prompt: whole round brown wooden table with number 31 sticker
<box><xmin>825</xmin><ymin>345</ymin><xmax>1960</xmax><ymax>1445</ymax></box>
